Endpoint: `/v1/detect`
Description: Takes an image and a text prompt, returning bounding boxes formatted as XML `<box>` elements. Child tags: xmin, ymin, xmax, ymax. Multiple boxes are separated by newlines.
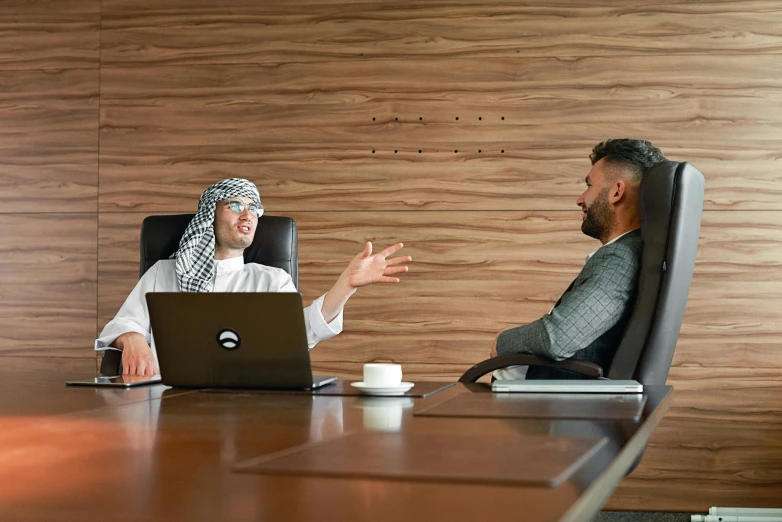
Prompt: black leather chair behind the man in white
<box><xmin>100</xmin><ymin>214</ymin><xmax>299</xmax><ymax>375</ymax></box>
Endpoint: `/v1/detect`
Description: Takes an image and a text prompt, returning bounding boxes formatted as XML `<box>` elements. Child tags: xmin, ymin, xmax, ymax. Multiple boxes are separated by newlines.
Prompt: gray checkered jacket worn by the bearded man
<box><xmin>497</xmin><ymin>230</ymin><xmax>643</xmax><ymax>379</ymax></box>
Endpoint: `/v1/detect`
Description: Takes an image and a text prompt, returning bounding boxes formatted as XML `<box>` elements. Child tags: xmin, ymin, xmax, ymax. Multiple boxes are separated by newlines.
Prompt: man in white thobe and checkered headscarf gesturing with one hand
<box><xmin>95</xmin><ymin>178</ymin><xmax>412</xmax><ymax>375</ymax></box>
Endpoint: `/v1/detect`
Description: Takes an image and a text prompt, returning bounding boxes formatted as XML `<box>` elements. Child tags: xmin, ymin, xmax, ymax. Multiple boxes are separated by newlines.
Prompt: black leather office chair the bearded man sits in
<box><xmin>459</xmin><ymin>161</ymin><xmax>704</xmax><ymax>385</ymax></box>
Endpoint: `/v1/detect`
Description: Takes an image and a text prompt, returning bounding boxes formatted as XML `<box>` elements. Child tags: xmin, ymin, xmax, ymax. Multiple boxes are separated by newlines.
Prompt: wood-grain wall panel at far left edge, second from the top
<box><xmin>0</xmin><ymin>68</ymin><xmax>99</xmax><ymax>213</ymax></box>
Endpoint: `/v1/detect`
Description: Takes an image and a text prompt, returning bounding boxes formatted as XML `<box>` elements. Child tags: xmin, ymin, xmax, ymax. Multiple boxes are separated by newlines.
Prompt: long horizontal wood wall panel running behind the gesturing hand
<box><xmin>99</xmin><ymin>212</ymin><xmax>782</xmax><ymax>367</ymax></box>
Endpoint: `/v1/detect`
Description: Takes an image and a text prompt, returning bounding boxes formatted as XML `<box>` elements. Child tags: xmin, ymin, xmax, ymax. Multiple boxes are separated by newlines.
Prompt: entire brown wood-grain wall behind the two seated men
<box><xmin>0</xmin><ymin>0</ymin><xmax>782</xmax><ymax>511</ymax></box>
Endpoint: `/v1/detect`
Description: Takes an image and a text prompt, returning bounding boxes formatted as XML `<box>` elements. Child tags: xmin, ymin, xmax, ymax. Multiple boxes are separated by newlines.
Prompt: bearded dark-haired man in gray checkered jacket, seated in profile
<box><xmin>491</xmin><ymin>139</ymin><xmax>665</xmax><ymax>379</ymax></box>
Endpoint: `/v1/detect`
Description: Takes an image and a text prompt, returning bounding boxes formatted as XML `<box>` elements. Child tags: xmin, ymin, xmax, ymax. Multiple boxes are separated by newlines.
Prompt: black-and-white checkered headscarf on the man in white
<box><xmin>171</xmin><ymin>178</ymin><xmax>261</xmax><ymax>292</ymax></box>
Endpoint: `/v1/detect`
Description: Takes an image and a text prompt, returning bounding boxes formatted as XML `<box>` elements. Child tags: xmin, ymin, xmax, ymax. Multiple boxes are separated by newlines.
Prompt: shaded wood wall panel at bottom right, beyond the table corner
<box><xmin>606</xmin><ymin>364</ymin><xmax>782</xmax><ymax>512</ymax></box>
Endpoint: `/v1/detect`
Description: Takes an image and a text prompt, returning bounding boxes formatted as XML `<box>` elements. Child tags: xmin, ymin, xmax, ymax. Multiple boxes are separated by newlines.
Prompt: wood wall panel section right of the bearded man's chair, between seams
<box><xmin>673</xmin><ymin>212</ymin><xmax>782</xmax><ymax>366</ymax></box>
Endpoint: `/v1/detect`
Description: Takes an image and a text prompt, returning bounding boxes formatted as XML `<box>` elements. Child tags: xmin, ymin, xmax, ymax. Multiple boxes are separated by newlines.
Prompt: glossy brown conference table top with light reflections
<box><xmin>0</xmin><ymin>358</ymin><xmax>672</xmax><ymax>522</ymax></box>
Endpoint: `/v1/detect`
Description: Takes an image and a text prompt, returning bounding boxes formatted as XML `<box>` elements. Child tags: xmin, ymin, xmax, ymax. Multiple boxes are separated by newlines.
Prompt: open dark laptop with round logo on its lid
<box><xmin>146</xmin><ymin>292</ymin><xmax>337</xmax><ymax>390</ymax></box>
